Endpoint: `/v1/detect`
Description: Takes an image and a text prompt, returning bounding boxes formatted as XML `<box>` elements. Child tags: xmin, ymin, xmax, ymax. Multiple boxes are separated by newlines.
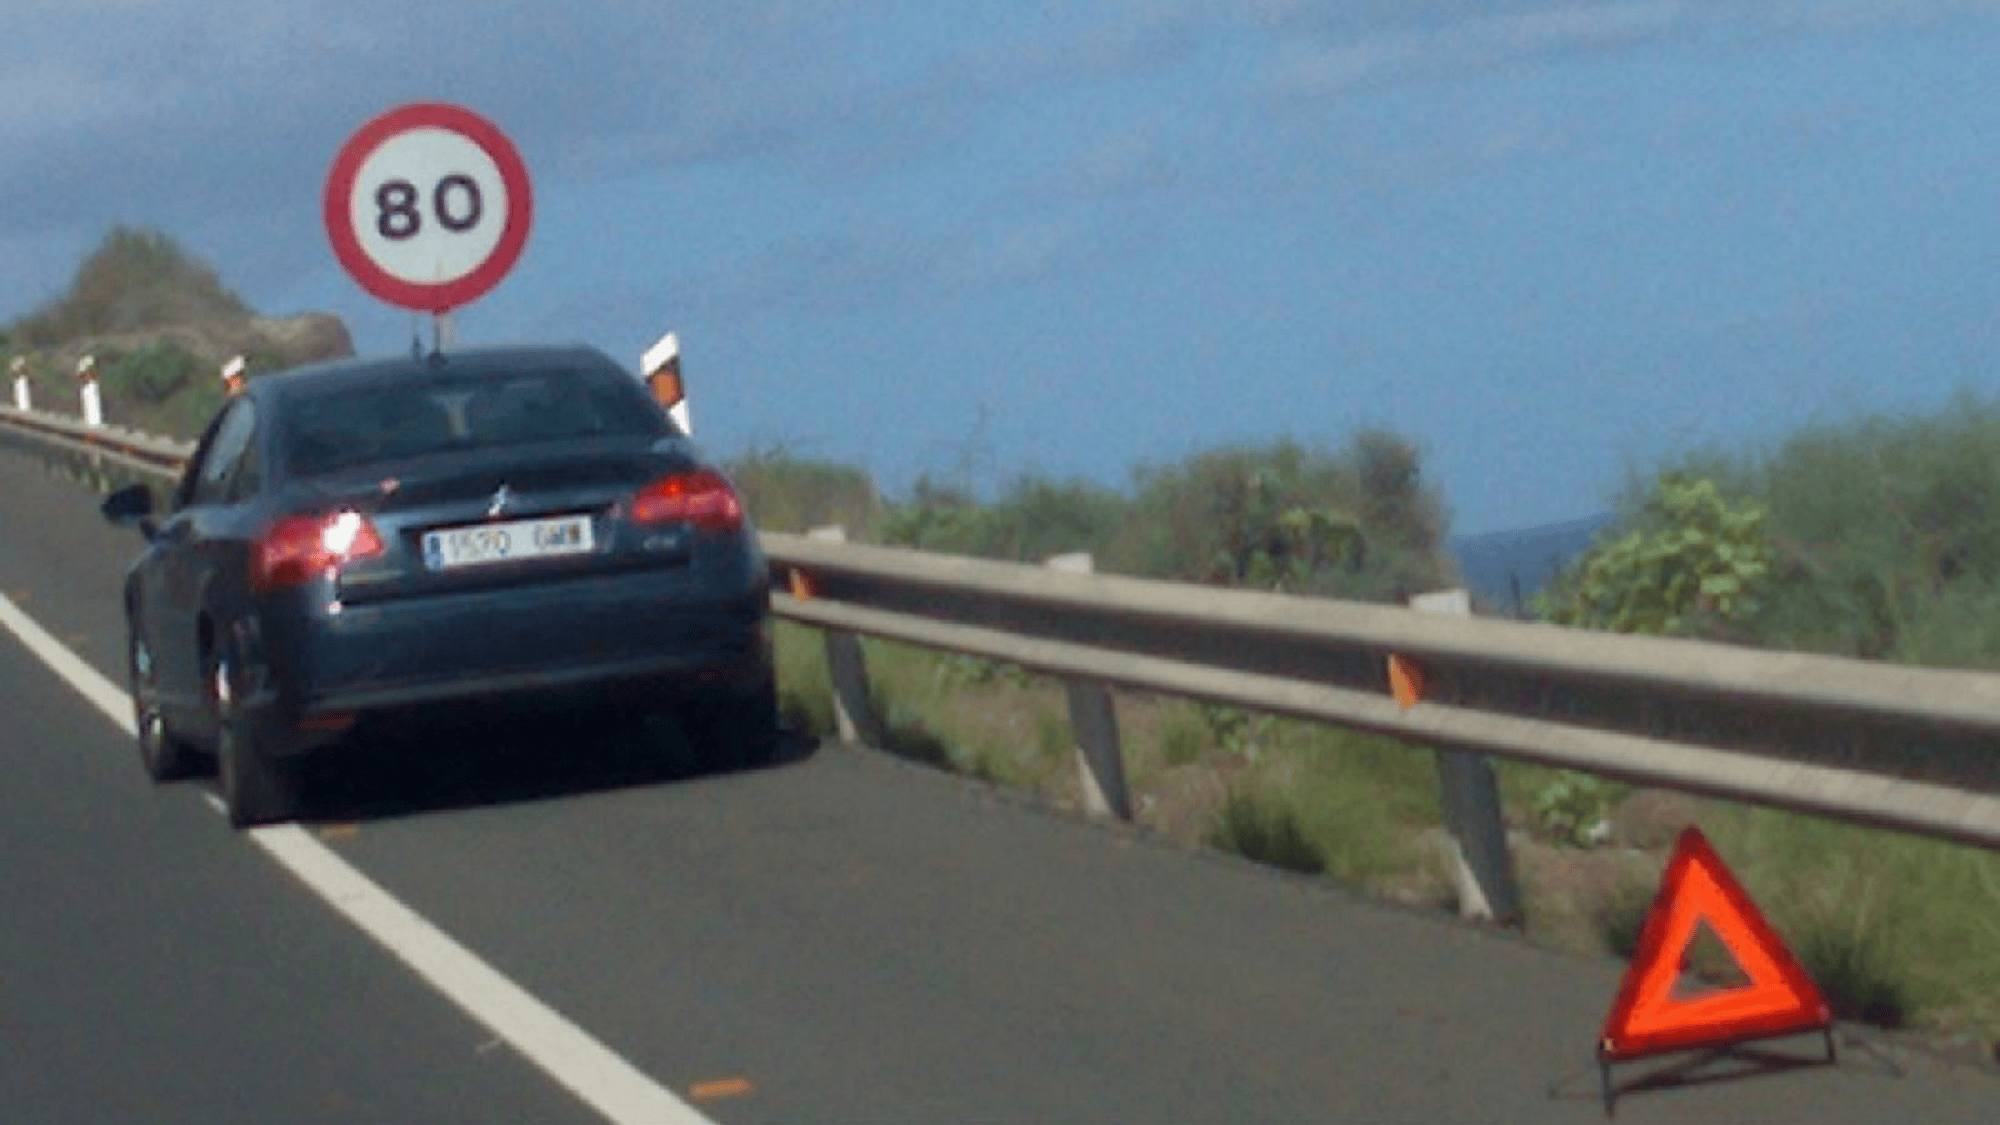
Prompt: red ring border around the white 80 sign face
<box><xmin>320</xmin><ymin>102</ymin><xmax>534</xmax><ymax>314</ymax></box>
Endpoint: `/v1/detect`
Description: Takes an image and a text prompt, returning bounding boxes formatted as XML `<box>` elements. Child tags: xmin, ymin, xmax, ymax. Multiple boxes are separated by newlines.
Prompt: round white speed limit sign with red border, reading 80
<box><xmin>322</xmin><ymin>102</ymin><xmax>534</xmax><ymax>314</ymax></box>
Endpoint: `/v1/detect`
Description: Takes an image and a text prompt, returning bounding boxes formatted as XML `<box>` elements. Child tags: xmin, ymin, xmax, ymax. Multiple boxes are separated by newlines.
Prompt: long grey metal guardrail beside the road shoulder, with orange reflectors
<box><xmin>11</xmin><ymin>408</ymin><xmax>2000</xmax><ymax>868</ymax></box>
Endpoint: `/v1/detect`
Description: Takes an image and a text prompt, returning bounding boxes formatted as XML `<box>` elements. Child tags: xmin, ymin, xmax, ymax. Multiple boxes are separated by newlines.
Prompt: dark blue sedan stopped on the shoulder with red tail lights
<box><xmin>104</xmin><ymin>348</ymin><xmax>778</xmax><ymax>825</ymax></box>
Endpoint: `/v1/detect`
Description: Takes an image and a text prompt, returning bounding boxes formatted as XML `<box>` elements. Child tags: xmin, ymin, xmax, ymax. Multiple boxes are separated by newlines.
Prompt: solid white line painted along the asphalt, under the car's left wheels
<box><xmin>0</xmin><ymin>595</ymin><xmax>714</xmax><ymax>1125</ymax></box>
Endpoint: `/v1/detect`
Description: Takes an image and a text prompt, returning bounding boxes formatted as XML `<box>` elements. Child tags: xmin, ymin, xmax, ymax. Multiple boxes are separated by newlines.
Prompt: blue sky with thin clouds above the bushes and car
<box><xmin>0</xmin><ymin>0</ymin><xmax>2000</xmax><ymax>532</ymax></box>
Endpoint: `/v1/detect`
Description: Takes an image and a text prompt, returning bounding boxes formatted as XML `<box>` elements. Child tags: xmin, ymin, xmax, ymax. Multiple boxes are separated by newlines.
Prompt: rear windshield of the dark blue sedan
<box><xmin>282</xmin><ymin>358</ymin><xmax>668</xmax><ymax>476</ymax></box>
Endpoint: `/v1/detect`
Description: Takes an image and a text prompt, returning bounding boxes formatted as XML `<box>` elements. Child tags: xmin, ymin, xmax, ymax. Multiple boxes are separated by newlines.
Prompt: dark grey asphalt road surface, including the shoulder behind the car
<box><xmin>0</xmin><ymin>442</ymin><xmax>2000</xmax><ymax>1123</ymax></box>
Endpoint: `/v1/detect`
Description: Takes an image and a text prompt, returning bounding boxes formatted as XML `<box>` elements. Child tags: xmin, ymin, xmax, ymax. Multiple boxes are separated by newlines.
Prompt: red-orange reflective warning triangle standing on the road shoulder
<box><xmin>1598</xmin><ymin>827</ymin><xmax>1834</xmax><ymax>1061</ymax></box>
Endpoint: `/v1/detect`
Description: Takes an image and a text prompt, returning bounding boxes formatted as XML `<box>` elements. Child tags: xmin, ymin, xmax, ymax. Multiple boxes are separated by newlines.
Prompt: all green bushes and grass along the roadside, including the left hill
<box><xmin>15</xmin><ymin>228</ymin><xmax>2000</xmax><ymax>1039</ymax></box>
